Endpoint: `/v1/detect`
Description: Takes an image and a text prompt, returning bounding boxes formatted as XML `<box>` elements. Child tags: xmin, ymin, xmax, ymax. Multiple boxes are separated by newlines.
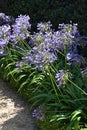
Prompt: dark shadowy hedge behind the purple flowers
<box><xmin>0</xmin><ymin>0</ymin><xmax>87</xmax><ymax>35</ymax></box>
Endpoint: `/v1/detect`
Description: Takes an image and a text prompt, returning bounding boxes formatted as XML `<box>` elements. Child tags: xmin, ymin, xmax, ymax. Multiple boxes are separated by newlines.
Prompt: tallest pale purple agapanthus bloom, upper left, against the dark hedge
<box><xmin>10</xmin><ymin>15</ymin><xmax>31</xmax><ymax>43</ymax></box>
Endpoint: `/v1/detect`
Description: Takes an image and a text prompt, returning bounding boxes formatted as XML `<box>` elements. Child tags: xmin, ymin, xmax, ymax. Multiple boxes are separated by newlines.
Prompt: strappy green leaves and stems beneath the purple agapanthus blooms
<box><xmin>0</xmin><ymin>17</ymin><xmax>87</xmax><ymax>130</ymax></box>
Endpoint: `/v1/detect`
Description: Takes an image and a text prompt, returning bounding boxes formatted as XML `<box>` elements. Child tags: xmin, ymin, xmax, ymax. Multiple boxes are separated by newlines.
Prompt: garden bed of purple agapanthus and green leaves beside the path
<box><xmin>0</xmin><ymin>13</ymin><xmax>87</xmax><ymax>130</ymax></box>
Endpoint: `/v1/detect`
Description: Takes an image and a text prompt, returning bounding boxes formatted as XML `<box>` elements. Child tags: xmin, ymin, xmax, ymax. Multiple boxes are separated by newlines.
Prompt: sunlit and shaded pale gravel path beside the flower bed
<box><xmin>0</xmin><ymin>79</ymin><xmax>39</xmax><ymax>130</ymax></box>
